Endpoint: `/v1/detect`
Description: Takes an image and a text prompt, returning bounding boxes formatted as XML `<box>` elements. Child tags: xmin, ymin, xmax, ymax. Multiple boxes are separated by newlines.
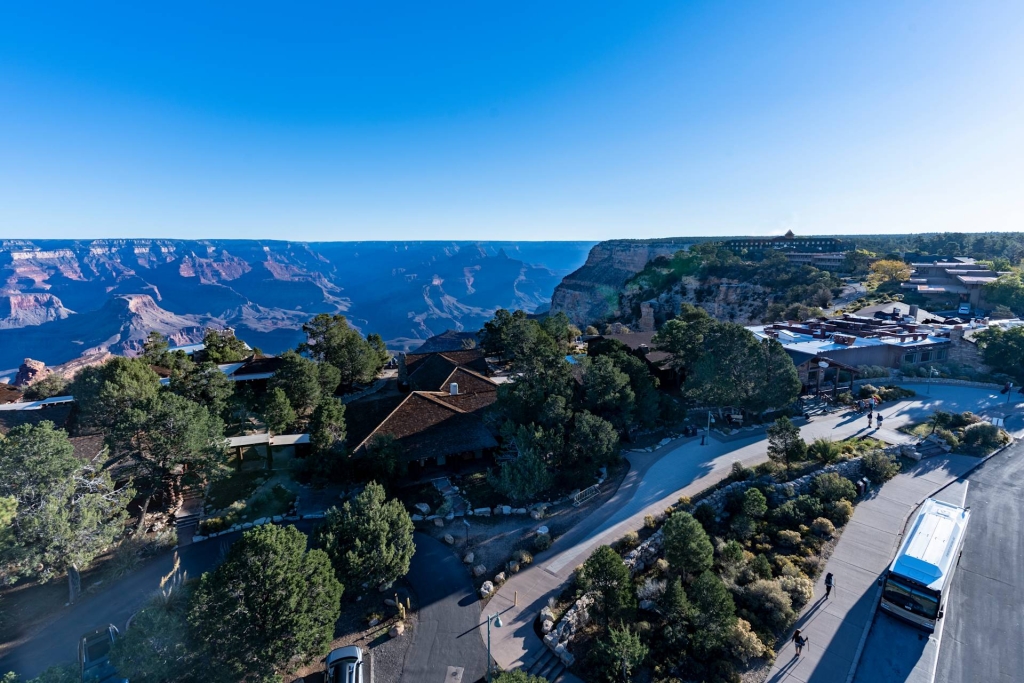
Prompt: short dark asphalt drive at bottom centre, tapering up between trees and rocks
<box><xmin>401</xmin><ymin>533</ymin><xmax>487</xmax><ymax>683</ymax></box>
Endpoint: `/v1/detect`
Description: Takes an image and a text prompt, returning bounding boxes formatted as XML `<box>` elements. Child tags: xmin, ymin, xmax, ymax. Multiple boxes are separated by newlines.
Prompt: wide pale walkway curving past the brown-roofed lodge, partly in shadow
<box><xmin>481</xmin><ymin>384</ymin><xmax>1024</xmax><ymax>669</ymax></box>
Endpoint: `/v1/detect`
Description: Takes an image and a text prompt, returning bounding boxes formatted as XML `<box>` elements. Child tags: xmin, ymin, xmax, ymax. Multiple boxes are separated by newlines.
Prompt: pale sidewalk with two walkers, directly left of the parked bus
<box><xmin>768</xmin><ymin>455</ymin><xmax>980</xmax><ymax>683</ymax></box>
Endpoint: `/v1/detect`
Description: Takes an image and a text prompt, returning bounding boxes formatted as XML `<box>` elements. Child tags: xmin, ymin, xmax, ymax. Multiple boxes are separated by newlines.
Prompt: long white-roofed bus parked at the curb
<box><xmin>882</xmin><ymin>499</ymin><xmax>971</xmax><ymax>631</ymax></box>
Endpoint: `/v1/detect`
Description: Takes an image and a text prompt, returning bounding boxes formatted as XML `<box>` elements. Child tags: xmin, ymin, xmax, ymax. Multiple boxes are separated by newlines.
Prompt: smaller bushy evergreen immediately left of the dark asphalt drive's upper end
<box><xmin>315</xmin><ymin>481</ymin><xmax>416</xmax><ymax>587</ymax></box>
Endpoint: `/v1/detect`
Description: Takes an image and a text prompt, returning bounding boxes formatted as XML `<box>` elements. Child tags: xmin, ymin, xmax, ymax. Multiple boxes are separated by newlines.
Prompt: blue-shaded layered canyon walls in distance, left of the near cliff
<box><xmin>0</xmin><ymin>240</ymin><xmax>594</xmax><ymax>371</ymax></box>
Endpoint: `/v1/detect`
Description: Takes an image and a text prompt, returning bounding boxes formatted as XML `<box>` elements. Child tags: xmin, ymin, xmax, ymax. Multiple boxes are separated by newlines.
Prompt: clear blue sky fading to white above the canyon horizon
<box><xmin>0</xmin><ymin>0</ymin><xmax>1024</xmax><ymax>241</ymax></box>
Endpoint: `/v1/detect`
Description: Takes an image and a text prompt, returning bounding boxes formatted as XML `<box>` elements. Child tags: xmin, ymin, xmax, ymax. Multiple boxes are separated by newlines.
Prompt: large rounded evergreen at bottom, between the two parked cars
<box><xmin>188</xmin><ymin>524</ymin><xmax>343</xmax><ymax>683</ymax></box>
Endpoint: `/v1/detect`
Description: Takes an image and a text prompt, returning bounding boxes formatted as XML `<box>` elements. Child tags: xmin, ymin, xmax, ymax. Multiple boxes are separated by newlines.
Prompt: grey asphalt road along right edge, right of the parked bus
<box><xmin>935</xmin><ymin>443</ymin><xmax>1024</xmax><ymax>683</ymax></box>
